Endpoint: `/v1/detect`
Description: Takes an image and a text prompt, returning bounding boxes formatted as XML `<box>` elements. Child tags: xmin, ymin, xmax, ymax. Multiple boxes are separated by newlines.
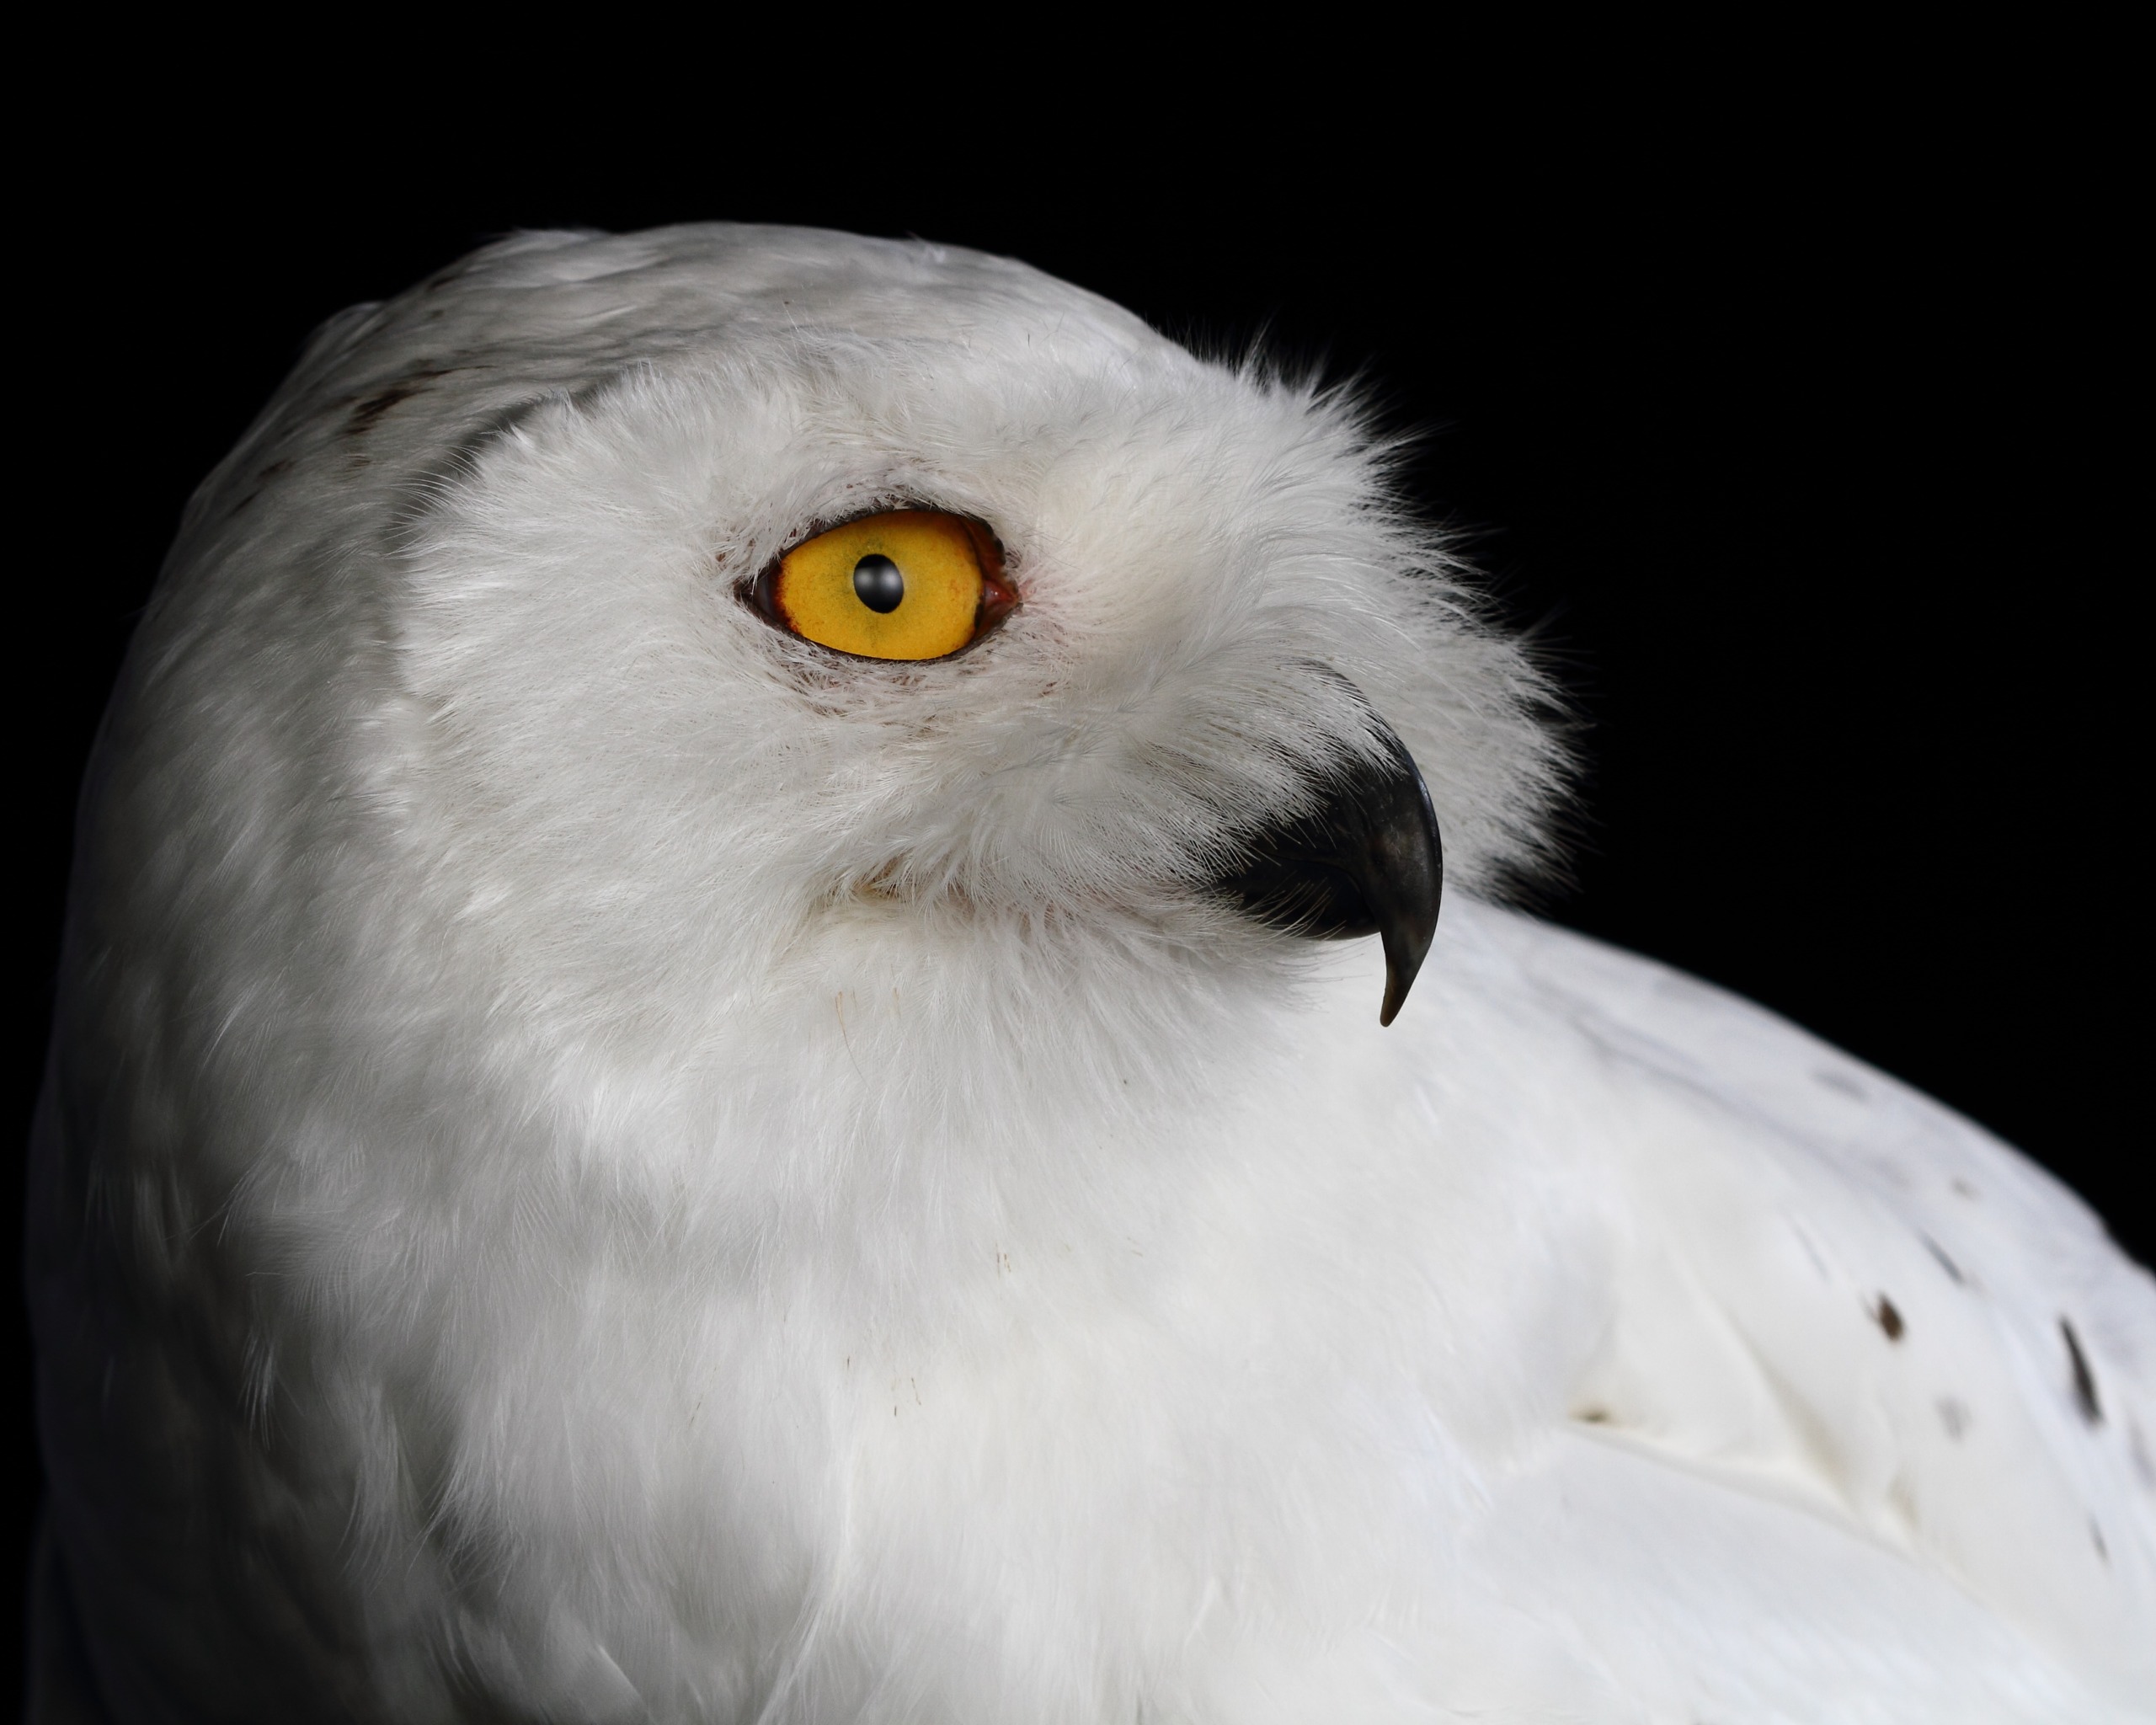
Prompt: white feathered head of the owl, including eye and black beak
<box><xmin>88</xmin><ymin>224</ymin><xmax>1561</xmax><ymax>1199</ymax></box>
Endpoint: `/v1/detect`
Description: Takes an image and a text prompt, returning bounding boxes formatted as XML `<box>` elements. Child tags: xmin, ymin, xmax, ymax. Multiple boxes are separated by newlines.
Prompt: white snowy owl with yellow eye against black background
<box><xmin>28</xmin><ymin>227</ymin><xmax>2156</xmax><ymax>1725</ymax></box>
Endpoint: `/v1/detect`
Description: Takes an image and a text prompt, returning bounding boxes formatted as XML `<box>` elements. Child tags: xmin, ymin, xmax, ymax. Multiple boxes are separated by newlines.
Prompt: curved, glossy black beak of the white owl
<box><xmin>1216</xmin><ymin>716</ymin><xmax>1444</xmax><ymax>1024</ymax></box>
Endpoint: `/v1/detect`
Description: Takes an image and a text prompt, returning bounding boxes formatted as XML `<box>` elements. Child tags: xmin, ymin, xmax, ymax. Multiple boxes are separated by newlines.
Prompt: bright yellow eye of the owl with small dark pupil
<box><xmin>757</xmin><ymin>509</ymin><xmax>1017</xmax><ymax>660</ymax></box>
